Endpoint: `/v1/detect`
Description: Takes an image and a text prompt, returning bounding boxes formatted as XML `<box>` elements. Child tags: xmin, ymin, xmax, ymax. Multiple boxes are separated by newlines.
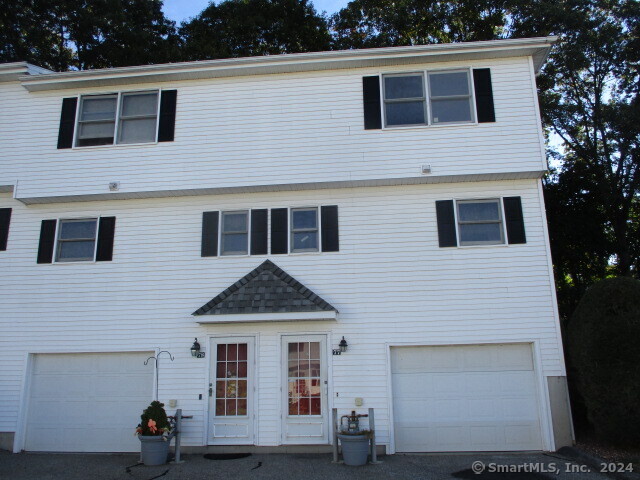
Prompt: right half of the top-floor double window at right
<box><xmin>429</xmin><ymin>70</ymin><xmax>473</xmax><ymax>124</ymax></box>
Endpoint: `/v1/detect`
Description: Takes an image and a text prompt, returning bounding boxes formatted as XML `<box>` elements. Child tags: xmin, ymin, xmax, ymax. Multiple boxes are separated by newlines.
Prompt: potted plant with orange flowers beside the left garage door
<box><xmin>136</xmin><ymin>400</ymin><xmax>171</xmax><ymax>465</ymax></box>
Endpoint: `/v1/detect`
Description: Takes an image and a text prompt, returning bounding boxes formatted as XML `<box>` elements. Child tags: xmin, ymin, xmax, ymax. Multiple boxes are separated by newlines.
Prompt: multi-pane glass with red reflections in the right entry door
<box><xmin>287</xmin><ymin>342</ymin><xmax>322</xmax><ymax>416</ymax></box>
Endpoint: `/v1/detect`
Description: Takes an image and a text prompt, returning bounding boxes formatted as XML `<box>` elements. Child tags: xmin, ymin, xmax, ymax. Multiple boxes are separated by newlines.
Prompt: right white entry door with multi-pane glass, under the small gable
<box><xmin>282</xmin><ymin>335</ymin><xmax>329</xmax><ymax>445</ymax></box>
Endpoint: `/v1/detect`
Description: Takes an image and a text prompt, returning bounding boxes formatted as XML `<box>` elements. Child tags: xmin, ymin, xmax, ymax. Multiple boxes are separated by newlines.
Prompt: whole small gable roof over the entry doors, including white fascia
<box><xmin>192</xmin><ymin>260</ymin><xmax>338</xmax><ymax>323</ymax></box>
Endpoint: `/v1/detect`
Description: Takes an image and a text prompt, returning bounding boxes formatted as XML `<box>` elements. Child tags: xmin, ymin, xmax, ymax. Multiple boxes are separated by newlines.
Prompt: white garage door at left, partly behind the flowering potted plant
<box><xmin>25</xmin><ymin>352</ymin><xmax>153</xmax><ymax>452</ymax></box>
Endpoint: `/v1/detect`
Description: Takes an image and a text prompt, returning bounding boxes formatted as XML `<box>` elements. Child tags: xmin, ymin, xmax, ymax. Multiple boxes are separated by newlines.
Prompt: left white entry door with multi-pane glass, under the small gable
<box><xmin>209</xmin><ymin>337</ymin><xmax>255</xmax><ymax>445</ymax></box>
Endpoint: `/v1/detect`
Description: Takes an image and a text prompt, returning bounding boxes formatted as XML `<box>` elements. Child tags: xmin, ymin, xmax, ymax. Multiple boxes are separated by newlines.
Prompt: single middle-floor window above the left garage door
<box><xmin>56</xmin><ymin>218</ymin><xmax>98</xmax><ymax>262</ymax></box>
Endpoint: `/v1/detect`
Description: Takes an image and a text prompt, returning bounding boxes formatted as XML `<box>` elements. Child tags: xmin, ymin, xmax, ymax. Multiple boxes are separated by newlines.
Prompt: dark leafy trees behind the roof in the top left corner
<box><xmin>0</xmin><ymin>0</ymin><xmax>179</xmax><ymax>71</ymax></box>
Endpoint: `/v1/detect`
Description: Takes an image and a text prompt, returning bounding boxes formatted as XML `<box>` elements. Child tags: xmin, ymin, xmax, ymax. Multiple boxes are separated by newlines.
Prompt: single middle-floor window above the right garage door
<box><xmin>456</xmin><ymin>199</ymin><xmax>504</xmax><ymax>245</ymax></box>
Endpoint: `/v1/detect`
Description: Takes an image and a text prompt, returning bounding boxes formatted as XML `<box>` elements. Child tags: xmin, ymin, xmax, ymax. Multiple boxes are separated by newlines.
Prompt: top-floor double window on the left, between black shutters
<box><xmin>76</xmin><ymin>91</ymin><xmax>158</xmax><ymax>147</ymax></box>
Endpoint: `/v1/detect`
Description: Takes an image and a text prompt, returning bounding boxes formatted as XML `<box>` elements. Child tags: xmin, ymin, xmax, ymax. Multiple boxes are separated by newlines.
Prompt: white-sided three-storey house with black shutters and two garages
<box><xmin>0</xmin><ymin>37</ymin><xmax>572</xmax><ymax>453</ymax></box>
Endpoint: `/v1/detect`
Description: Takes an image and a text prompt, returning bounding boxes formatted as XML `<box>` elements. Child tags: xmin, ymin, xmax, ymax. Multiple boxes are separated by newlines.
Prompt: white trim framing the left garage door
<box><xmin>13</xmin><ymin>347</ymin><xmax>159</xmax><ymax>453</ymax></box>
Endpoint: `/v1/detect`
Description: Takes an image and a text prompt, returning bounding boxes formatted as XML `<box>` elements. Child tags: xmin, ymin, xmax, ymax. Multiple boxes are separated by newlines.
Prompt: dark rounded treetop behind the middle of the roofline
<box><xmin>180</xmin><ymin>0</ymin><xmax>331</xmax><ymax>60</ymax></box>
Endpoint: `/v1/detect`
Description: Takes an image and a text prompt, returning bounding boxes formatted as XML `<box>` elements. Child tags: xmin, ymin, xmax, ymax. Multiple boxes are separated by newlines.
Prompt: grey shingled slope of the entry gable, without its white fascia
<box><xmin>192</xmin><ymin>260</ymin><xmax>337</xmax><ymax>315</ymax></box>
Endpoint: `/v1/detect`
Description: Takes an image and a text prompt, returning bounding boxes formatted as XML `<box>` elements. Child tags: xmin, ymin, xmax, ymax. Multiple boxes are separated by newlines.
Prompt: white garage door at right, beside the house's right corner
<box><xmin>391</xmin><ymin>344</ymin><xmax>542</xmax><ymax>452</ymax></box>
